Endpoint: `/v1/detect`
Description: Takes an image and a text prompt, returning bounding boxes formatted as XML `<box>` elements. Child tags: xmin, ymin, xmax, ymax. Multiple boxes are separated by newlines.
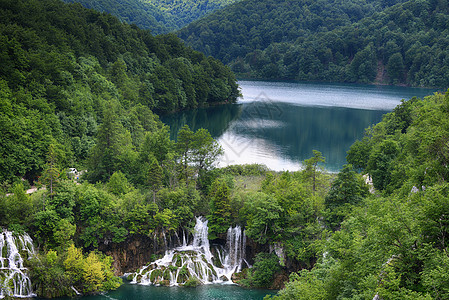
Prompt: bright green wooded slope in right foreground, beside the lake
<box><xmin>271</xmin><ymin>94</ymin><xmax>449</xmax><ymax>299</ymax></box>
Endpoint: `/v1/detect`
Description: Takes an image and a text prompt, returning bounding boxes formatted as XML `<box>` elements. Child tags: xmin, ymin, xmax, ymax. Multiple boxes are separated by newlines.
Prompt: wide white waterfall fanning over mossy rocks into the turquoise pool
<box><xmin>131</xmin><ymin>217</ymin><xmax>246</xmax><ymax>286</ymax></box>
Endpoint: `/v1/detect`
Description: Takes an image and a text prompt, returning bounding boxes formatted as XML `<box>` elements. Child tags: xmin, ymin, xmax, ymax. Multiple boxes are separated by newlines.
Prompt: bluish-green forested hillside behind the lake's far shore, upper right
<box><xmin>179</xmin><ymin>0</ymin><xmax>449</xmax><ymax>87</ymax></box>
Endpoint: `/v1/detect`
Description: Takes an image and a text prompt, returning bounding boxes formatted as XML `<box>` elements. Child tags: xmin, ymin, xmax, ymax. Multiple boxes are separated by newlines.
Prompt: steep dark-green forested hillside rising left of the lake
<box><xmin>0</xmin><ymin>0</ymin><xmax>239</xmax><ymax>183</ymax></box>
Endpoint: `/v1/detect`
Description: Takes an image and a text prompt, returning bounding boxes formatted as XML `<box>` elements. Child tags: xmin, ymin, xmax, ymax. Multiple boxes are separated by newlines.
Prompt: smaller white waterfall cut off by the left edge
<box><xmin>0</xmin><ymin>231</ymin><xmax>35</xmax><ymax>299</ymax></box>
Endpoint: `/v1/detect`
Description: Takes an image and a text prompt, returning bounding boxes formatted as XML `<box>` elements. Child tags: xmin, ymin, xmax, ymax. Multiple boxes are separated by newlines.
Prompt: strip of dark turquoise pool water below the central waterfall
<box><xmin>43</xmin><ymin>283</ymin><xmax>275</xmax><ymax>300</ymax></box>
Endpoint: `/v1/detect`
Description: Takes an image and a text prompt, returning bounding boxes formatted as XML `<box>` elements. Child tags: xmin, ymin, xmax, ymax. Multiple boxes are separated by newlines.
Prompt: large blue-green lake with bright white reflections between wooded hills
<box><xmin>161</xmin><ymin>81</ymin><xmax>435</xmax><ymax>172</ymax></box>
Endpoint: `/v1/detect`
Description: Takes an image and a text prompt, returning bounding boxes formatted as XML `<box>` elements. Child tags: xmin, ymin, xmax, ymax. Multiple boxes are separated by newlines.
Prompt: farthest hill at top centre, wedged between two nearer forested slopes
<box><xmin>63</xmin><ymin>0</ymin><xmax>239</xmax><ymax>34</ymax></box>
